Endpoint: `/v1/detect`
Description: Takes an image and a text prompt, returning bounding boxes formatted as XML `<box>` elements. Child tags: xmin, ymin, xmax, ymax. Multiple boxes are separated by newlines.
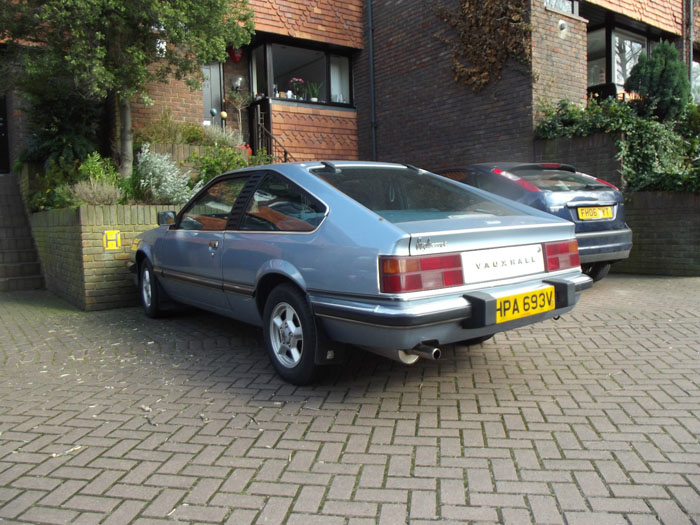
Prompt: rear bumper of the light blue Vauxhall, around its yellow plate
<box><xmin>310</xmin><ymin>274</ymin><xmax>593</xmax><ymax>350</ymax></box>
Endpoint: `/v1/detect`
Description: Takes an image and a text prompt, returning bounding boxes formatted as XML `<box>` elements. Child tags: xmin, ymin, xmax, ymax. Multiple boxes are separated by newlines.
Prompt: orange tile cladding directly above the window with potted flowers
<box><xmin>249</xmin><ymin>0</ymin><xmax>364</xmax><ymax>48</ymax></box>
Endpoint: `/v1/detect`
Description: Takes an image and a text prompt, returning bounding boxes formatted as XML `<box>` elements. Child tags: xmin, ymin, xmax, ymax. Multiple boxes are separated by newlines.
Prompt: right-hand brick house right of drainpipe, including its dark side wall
<box><xmin>355</xmin><ymin>0</ymin><xmax>700</xmax><ymax>169</ymax></box>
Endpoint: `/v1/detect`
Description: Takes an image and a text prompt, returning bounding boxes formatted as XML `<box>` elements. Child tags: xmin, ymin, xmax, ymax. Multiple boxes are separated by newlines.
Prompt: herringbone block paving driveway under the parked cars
<box><xmin>0</xmin><ymin>275</ymin><xmax>700</xmax><ymax>525</ymax></box>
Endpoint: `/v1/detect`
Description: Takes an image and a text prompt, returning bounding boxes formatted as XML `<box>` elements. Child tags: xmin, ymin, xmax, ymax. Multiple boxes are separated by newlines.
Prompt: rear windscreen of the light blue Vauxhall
<box><xmin>312</xmin><ymin>166</ymin><xmax>518</xmax><ymax>223</ymax></box>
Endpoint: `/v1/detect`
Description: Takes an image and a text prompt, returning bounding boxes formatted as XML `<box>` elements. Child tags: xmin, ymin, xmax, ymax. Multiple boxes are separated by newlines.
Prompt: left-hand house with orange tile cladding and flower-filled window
<box><xmin>133</xmin><ymin>0</ymin><xmax>363</xmax><ymax>160</ymax></box>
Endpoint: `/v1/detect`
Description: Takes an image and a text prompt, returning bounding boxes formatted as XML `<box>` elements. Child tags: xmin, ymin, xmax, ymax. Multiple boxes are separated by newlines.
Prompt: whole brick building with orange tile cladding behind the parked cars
<box><xmin>0</xmin><ymin>0</ymin><xmax>700</xmax><ymax>172</ymax></box>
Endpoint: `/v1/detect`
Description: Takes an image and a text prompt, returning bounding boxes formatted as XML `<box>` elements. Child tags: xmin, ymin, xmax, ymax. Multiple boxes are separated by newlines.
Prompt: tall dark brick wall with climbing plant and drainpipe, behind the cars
<box><xmin>355</xmin><ymin>0</ymin><xmax>533</xmax><ymax>169</ymax></box>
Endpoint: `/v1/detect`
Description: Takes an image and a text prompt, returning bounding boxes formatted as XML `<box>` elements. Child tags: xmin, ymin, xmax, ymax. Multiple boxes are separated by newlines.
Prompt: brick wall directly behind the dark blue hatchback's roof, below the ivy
<box><xmin>534</xmin><ymin>133</ymin><xmax>622</xmax><ymax>188</ymax></box>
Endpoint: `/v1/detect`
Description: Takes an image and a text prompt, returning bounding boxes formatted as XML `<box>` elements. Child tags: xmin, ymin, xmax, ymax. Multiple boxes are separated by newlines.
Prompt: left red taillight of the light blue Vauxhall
<box><xmin>379</xmin><ymin>254</ymin><xmax>464</xmax><ymax>293</ymax></box>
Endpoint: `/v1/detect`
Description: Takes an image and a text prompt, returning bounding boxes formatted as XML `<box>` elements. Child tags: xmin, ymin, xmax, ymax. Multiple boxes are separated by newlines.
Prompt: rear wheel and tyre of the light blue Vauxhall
<box><xmin>263</xmin><ymin>284</ymin><xmax>318</xmax><ymax>385</ymax></box>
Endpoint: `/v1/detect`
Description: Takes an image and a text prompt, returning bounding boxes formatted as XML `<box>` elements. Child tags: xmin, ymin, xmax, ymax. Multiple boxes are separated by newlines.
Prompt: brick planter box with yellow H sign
<box><xmin>30</xmin><ymin>205</ymin><xmax>173</xmax><ymax>311</ymax></box>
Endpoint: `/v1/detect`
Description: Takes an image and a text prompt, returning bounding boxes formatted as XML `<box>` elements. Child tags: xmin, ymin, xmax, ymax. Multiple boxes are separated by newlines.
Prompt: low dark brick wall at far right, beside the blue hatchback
<box><xmin>612</xmin><ymin>192</ymin><xmax>700</xmax><ymax>276</ymax></box>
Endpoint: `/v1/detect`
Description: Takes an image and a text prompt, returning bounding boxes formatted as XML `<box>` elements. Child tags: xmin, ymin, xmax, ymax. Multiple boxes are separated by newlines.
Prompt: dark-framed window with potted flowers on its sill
<box><xmin>253</xmin><ymin>44</ymin><xmax>352</xmax><ymax>105</ymax></box>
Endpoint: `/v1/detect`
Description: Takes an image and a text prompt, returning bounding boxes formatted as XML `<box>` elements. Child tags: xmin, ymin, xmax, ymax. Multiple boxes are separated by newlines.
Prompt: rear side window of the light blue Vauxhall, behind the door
<box><xmin>240</xmin><ymin>173</ymin><xmax>326</xmax><ymax>232</ymax></box>
